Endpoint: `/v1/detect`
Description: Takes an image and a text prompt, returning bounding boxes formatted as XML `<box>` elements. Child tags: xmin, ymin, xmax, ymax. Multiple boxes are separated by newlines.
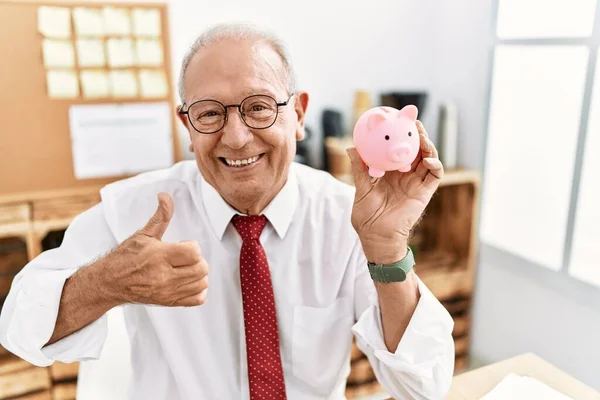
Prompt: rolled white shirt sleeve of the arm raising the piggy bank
<box><xmin>352</xmin><ymin>241</ymin><xmax>454</xmax><ymax>400</ymax></box>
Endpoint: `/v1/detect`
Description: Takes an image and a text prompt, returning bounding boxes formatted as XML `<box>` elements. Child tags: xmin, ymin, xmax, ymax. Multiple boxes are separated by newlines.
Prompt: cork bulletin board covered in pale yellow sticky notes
<box><xmin>0</xmin><ymin>0</ymin><xmax>181</xmax><ymax>195</ymax></box>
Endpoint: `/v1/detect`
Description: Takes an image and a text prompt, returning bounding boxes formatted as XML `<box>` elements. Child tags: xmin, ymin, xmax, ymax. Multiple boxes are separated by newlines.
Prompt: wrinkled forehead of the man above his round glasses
<box><xmin>184</xmin><ymin>39</ymin><xmax>287</xmax><ymax>104</ymax></box>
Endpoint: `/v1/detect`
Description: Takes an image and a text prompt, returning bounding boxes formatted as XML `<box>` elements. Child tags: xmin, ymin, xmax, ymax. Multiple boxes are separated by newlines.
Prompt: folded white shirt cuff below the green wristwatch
<box><xmin>353</xmin><ymin>277</ymin><xmax>454</xmax><ymax>380</ymax></box>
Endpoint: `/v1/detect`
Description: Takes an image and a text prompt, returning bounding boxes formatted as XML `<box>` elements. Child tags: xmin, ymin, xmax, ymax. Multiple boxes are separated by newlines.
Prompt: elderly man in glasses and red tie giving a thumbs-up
<box><xmin>0</xmin><ymin>25</ymin><xmax>454</xmax><ymax>400</ymax></box>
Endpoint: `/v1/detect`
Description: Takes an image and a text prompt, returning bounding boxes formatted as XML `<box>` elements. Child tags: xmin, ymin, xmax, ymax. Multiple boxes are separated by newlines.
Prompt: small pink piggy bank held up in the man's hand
<box><xmin>353</xmin><ymin>105</ymin><xmax>420</xmax><ymax>178</ymax></box>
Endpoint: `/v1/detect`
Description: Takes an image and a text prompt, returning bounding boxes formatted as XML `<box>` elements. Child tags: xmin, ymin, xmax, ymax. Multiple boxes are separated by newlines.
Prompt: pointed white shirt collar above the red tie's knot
<box><xmin>200</xmin><ymin>163</ymin><xmax>299</xmax><ymax>240</ymax></box>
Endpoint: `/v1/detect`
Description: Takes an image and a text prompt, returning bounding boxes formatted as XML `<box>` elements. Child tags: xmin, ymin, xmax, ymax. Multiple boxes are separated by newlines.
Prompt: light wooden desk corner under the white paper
<box><xmin>447</xmin><ymin>353</ymin><xmax>600</xmax><ymax>400</ymax></box>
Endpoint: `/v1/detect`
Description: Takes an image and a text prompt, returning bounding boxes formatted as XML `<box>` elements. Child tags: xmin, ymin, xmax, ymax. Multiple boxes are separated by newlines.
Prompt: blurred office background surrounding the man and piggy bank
<box><xmin>0</xmin><ymin>0</ymin><xmax>600</xmax><ymax>399</ymax></box>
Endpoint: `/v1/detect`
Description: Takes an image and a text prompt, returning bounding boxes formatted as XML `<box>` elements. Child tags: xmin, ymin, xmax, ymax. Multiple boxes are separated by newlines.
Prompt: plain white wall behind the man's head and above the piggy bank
<box><xmin>170</xmin><ymin>0</ymin><xmax>448</xmax><ymax>166</ymax></box>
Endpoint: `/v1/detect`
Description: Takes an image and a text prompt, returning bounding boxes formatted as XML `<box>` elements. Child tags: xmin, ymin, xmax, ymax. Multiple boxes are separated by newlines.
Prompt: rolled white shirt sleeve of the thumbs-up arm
<box><xmin>0</xmin><ymin>204</ymin><xmax>117</xmax><ymax>366</ymax></box>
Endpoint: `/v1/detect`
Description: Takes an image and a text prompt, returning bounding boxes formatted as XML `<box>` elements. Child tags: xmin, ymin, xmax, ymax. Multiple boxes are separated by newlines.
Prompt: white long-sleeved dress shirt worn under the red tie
<box><xmin>0</xmin><ymin>161</ymin><xmax>454</xmax><ymax>400</ymax></box>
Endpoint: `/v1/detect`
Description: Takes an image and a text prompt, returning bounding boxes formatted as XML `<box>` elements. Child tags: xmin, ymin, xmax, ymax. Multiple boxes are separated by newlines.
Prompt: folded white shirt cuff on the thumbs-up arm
<box><xmin>6</xmin><ymin>269</ymin><xmax>107</xmax><ymax>366</ymax></box>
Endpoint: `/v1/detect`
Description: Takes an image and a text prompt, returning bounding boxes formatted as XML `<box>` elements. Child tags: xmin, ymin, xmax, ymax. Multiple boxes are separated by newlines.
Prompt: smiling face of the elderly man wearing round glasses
<box><xmin>179</xmin><ymin>39</ymin><xmax>308</xmax><ymax>214</ymax></box>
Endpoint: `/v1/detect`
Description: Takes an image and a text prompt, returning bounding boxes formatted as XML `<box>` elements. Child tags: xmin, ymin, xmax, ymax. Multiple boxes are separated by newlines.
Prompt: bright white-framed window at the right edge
<box><xmin>480</xmin><ymin>0</ymin><xmax>600</xmax><ymax>286</ymax></box>
